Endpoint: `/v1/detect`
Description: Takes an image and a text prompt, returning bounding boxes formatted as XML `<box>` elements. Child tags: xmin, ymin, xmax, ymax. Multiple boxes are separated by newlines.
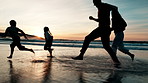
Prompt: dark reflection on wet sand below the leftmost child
<box><xmin>8</xmin><ymin>60</ymin><xmax>19</xmax><ymax>83</ymax></box>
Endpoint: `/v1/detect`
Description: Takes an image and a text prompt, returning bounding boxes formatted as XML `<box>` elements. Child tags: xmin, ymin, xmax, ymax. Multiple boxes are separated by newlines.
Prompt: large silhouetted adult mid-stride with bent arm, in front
<box><xmin>73</xmin><ymin>0</ymin><xmax>120</xmax><ymax>64</ymax></box>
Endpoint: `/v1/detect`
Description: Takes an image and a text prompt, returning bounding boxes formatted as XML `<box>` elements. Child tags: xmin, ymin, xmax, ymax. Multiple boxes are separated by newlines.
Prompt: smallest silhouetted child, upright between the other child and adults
<box><xmin>44</xmin><ymin>27</ymin><xmax>53</xmax><ymax>57</ymax></box>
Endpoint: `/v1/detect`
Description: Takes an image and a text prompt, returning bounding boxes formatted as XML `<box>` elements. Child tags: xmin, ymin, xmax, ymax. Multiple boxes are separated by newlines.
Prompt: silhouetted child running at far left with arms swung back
<box><xmin>4</xmin><ymin>20</ymin><xmax>34</xmax><ymax>58</ymax></box>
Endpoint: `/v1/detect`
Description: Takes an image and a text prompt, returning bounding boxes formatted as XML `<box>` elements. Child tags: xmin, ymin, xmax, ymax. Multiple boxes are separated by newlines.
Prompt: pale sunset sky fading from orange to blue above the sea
<box><xmin>0</xmin><ymin>0</ymin><xmax>148</xmax><ymax>41</ymax></box>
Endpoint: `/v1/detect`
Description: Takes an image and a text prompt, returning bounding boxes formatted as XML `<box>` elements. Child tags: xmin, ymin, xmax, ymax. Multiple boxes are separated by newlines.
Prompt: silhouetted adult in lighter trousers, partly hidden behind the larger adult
<box><xmin>112</xmin><ymin>9</ymin><xmax>135</xmax><ymax>61</ymax></box>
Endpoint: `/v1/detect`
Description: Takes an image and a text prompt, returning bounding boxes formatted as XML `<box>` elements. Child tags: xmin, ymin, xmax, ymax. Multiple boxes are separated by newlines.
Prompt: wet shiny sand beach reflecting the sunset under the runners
<box><xmin>0</xmin><ymin>44</ymin><xmax>148</xmax><ymax>83</ymax></box>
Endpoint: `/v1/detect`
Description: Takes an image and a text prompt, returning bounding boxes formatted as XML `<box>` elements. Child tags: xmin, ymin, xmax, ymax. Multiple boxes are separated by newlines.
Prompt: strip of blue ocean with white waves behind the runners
<box><xmin>0</xmin><ymin>39</ymin><xmax>148</xmax><ymax>50</ymax></box>
